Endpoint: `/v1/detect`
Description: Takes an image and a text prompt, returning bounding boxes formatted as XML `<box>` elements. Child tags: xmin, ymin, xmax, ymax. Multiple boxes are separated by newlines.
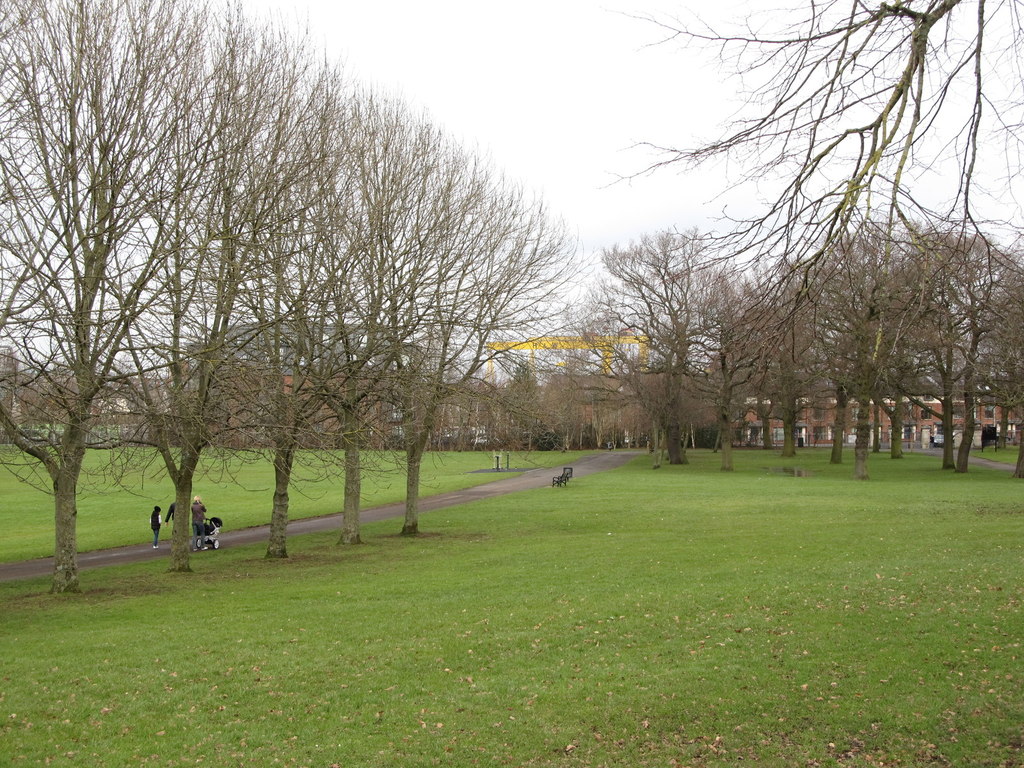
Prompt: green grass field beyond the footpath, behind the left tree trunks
<box><xmin>0</xmin><ymin>452</ymin><xmax>583</xmax><ymax>562</ymax></box>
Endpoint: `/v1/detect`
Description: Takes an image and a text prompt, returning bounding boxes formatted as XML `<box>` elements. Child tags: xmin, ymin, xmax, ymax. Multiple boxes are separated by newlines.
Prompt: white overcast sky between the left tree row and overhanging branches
<box><xmin>244</xmin><ymin>0</ymin><xmax>735</xmax><ymax>270</ymax></box>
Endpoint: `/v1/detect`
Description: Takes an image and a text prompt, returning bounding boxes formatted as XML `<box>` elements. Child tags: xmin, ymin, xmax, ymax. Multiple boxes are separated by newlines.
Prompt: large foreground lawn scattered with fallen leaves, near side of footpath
<box><xmin>0</xmin><ymin>451</ymin><xmax>1024</xmax><ymax>768</ymax></box>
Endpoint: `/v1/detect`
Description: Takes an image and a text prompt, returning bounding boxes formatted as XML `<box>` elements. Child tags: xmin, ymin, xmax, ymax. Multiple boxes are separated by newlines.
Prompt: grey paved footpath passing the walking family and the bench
<box><xmin>0</xmin><ymin>451</ymin><xmax>641</xmax><ymax>582</ymax></box>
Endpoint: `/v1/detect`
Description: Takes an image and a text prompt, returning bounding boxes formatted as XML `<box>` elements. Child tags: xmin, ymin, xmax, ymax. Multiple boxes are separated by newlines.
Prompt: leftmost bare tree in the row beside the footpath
<box><xmin>0</xmin><ymin>0</ymin><xmax>201</xmax><ymax>592</ymax></box>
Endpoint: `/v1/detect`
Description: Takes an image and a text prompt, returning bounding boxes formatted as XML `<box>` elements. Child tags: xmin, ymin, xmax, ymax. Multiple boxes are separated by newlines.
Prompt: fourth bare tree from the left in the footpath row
<box><xmin>325</xmin><ymin>92</ymin><xmax>435</xmax><ymax>545</ymax></box>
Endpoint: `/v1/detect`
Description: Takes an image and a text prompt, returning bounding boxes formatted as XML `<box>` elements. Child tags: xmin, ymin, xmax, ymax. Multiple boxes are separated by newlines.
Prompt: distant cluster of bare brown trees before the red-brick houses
<box><xmin>591</xmin><ymin>221</ymin><xmax>1024</xmax><ymax>479</ymax></box>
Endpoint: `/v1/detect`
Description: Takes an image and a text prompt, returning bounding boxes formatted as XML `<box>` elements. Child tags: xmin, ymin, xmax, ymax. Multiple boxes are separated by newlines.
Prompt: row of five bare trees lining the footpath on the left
<box><xmin>0</xmin><ymin>0</ymin><xmax>571</xmax><ymax>592</ymax></box>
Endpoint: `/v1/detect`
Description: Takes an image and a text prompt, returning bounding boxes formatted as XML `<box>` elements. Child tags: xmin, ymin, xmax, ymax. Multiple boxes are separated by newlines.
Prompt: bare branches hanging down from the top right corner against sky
<box><xmin>655</xmin><ymin>0</ymin><xmax>1024</xmax><ymax>278</ymax></box>
